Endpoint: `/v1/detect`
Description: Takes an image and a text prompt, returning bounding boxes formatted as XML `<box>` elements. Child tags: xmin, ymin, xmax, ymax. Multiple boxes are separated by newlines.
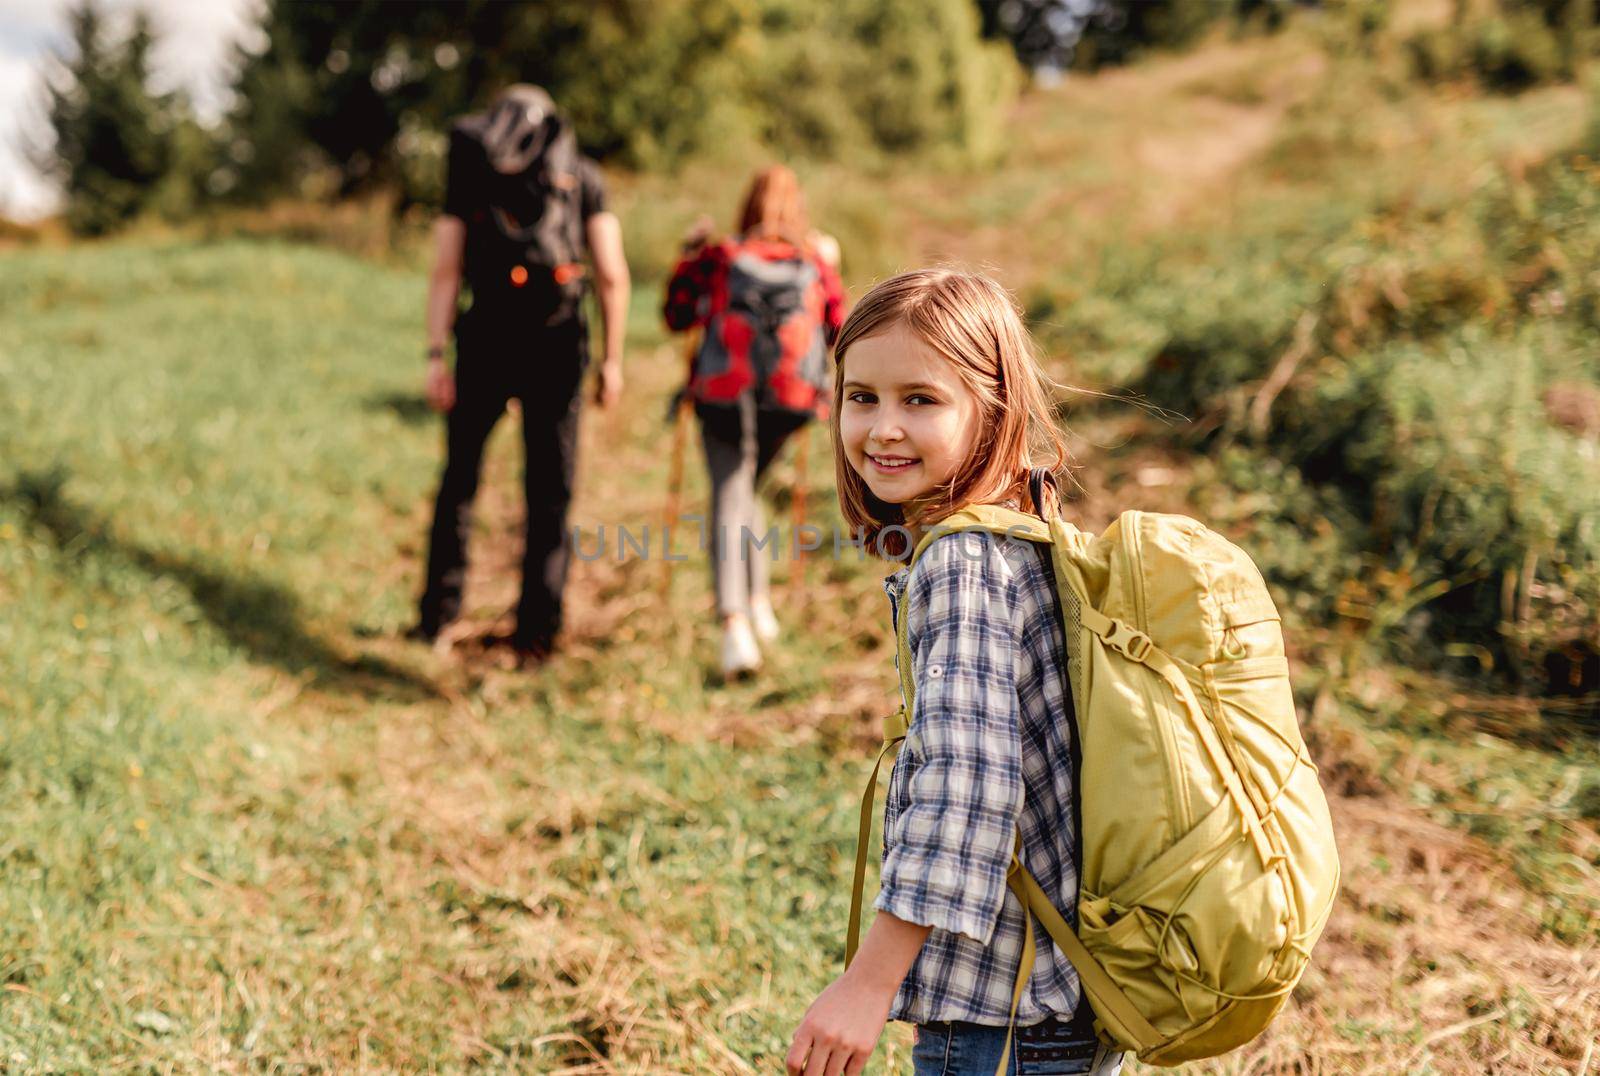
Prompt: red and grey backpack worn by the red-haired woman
<box><xmin>690</xmin><ymin>239</ymin><xmax>832</xmax><ymax>415</ymax></box>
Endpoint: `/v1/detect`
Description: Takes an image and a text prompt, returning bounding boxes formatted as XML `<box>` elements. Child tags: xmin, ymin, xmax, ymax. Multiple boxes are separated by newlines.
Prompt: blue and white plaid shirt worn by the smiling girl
<box><xmin>875</xmin><ymin>532</ymin><xmax>1078</xmax><ymax>1025</ymax></box>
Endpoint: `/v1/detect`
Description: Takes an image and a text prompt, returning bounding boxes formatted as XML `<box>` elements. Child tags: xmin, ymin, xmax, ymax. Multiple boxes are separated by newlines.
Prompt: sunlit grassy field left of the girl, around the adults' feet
<box><xmin>0</xmin><ymin>242</ymin><xmax>915</xmax><ymax>1071</ymax></box>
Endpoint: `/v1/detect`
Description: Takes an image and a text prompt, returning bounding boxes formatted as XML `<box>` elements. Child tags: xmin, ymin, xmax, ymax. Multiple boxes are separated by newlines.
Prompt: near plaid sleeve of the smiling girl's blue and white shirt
<box><xmin>877</xmin><ymin>533</ymin><xmax>1022</xmax><ymax>945</ymax></box>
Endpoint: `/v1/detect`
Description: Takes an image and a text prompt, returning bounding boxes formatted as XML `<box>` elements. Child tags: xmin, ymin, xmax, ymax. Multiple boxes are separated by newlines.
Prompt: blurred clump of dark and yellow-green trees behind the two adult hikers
<box><xmin>232</xmin><ymin>0</ymin><xmax>1014</xmax><ymax>203</ymax></box>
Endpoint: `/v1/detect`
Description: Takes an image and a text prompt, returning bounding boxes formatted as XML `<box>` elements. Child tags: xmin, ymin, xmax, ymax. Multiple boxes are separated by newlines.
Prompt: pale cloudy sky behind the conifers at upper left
<box><xmin>0</xmin><ymin>0</ymin><xmax>259</xmax><ymax>219</ymax></box>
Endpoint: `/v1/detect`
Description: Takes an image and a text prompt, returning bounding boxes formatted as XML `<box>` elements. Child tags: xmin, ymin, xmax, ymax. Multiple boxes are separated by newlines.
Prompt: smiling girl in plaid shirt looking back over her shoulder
<box><xmin>787</xmin><ymin>269</ymin><xmax>1120</xmax><ymax>1076</ymax></box>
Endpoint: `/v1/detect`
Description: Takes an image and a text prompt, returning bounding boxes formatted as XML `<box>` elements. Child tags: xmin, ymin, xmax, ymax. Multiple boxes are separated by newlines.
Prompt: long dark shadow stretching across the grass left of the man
<box><xmin>0</xmin><ymin>468</ymin><xmax>438</xmax><ymax>701</ymax></box>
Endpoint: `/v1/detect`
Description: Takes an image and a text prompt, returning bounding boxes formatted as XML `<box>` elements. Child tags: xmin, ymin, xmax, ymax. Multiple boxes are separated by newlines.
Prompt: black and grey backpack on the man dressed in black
<box><xmin>450</xmin><ymin>86</ymin><xmax>586</xmax><ymax>325</ymax></box>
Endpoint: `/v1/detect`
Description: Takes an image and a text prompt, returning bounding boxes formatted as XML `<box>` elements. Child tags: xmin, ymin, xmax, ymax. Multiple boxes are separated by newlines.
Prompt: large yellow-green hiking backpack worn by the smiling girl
<box><xmin>845</xmin><ymin>506</ymin><xmax>1339</xmax><ymax>1071</ymax></box>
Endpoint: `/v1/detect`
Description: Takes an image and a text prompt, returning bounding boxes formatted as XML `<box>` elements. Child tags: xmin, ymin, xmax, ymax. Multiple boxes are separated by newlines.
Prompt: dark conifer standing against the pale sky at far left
<box><xmin>37</xmin><ymin>0</ymin><xmax>192</xmax><ymax>235</ymax></box>
